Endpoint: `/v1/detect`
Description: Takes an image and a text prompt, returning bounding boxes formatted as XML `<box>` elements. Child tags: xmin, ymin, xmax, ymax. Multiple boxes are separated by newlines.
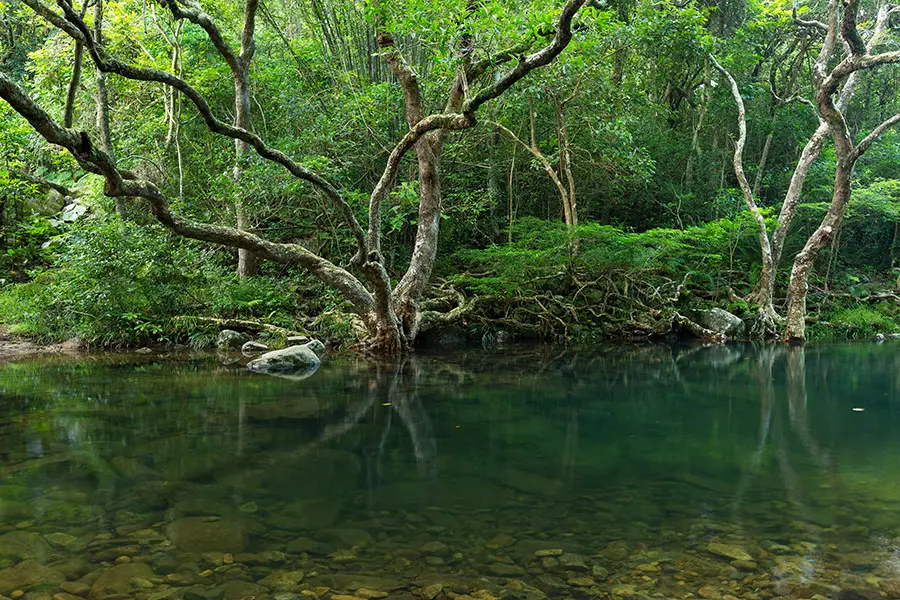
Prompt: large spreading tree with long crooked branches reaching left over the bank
<box><xmin>0</xmin><ymin>0</ymin><xmax>591</xmax><ymax>354</ymax></box>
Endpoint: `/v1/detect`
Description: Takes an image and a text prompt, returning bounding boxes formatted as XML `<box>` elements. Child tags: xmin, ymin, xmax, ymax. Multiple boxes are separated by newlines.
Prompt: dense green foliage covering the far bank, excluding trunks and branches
<box><xmin>0</xmin><ymin>0</ymin><xmax>900</xmax><ymax>345</ymax></box>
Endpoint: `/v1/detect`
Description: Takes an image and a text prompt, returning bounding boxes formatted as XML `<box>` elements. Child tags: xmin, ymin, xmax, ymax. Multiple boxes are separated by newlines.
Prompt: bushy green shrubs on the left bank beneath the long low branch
<box><xmin>0</xmin><ymin>218</ymin><xmax>310</xmax><ymax>346</ymax></box>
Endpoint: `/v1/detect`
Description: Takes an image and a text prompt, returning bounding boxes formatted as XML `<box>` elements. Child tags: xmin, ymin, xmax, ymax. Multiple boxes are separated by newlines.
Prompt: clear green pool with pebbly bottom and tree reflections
<box><xmin>0</xmin><ymin>344</ymin><xmax>900</xmax><ymax>600</ymax></box>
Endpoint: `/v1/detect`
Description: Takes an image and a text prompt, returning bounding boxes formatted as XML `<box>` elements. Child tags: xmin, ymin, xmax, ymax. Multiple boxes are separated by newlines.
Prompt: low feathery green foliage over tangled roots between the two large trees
<box><xmin>450</xmin><ymin>213</ymin><xmax>768</xmax><ymax>341</ymax></box>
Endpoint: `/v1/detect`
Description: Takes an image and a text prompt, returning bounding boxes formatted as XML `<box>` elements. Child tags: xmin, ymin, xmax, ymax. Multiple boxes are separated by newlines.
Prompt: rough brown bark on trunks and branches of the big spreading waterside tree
<box><xmin>14</xmin><ymin>0</ymin><xmax>587</xmax><ymax>355</ymax></box>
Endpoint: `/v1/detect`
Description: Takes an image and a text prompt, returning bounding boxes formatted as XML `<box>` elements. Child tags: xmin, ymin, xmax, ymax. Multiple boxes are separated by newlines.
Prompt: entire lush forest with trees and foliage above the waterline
<box><xmin>0</xmin><ymin>0</ymin><xmax>900</xmax><ymax>355</ymax></box>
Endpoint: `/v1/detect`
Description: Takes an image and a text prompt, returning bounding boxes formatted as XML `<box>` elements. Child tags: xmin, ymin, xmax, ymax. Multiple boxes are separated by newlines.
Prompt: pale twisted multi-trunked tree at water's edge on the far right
<box><xmin>710</xmin><ymin>0</ymin><xmax>900</xmax><ymax>341</ymax></box>
